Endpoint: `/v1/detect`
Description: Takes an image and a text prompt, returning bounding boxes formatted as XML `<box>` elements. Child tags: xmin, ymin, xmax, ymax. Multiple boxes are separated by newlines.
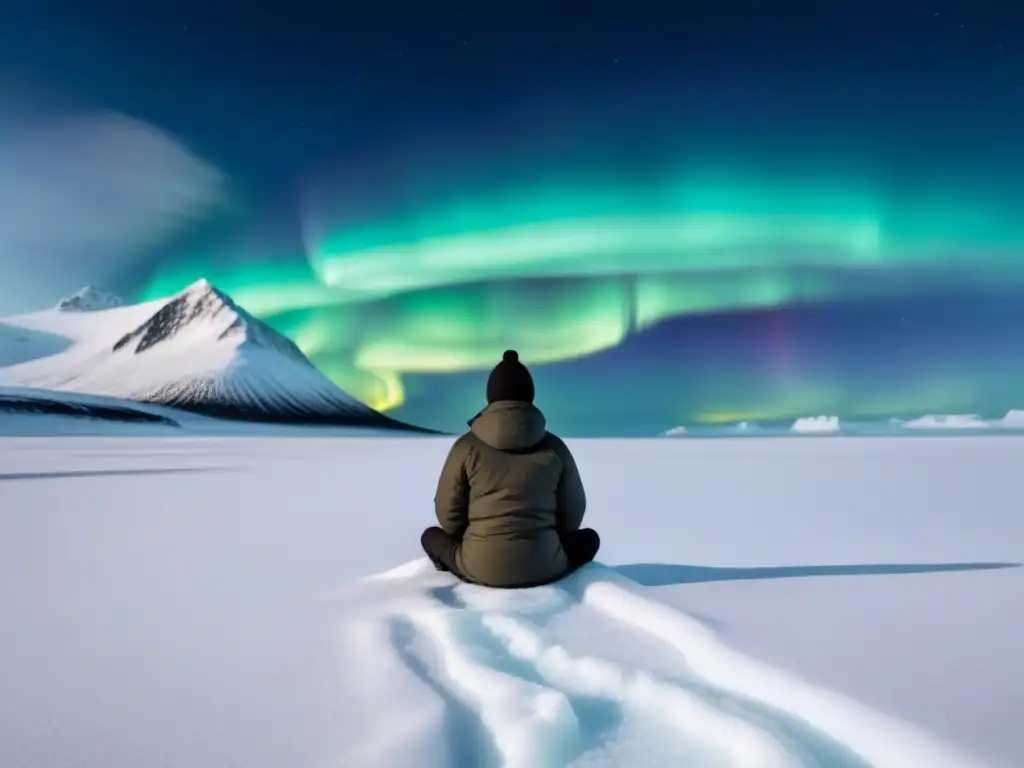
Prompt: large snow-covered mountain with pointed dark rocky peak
<box><xmin>0</xmin><ymin>280</ymin><xmax>432</xmax><ymax>429</ymax></box>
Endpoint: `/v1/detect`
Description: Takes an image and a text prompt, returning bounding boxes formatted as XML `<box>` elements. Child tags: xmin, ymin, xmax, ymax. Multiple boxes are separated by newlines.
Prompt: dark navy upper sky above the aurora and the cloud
<box><xmin>8</xmin><ymin>0</ymin><xmax>1024</xmax><ymax>194</ymax></box>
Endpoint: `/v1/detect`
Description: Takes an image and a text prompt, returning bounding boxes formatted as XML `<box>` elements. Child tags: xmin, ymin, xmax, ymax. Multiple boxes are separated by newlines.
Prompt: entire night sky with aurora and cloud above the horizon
<box><xmin>0</xmin><ymin>0</ymin><xmax>1024</xmax><ymax>434</ymax></box>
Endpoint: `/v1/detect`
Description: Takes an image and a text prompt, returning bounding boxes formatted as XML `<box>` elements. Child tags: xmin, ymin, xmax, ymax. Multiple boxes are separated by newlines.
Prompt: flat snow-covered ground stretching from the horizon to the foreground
<box><xmin>0</xmin><ymin>436</ymin><xmax>1024</xmax><ymax>768</ymax></box>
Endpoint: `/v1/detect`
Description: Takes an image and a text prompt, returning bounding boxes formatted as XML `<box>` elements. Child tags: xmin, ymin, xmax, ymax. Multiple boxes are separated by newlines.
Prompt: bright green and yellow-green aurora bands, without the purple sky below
<box><xmin>141</xmin><ymin>169</ymin><xmax>1024</xmax><ymax>426</ymax></box>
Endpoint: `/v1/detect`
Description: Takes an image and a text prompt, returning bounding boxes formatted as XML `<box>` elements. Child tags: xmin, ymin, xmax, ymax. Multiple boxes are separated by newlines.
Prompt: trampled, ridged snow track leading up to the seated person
<box><xmin>335</xmin><ymin>560</ymin><xmax>977</xmax><ymax>768</ymax></box>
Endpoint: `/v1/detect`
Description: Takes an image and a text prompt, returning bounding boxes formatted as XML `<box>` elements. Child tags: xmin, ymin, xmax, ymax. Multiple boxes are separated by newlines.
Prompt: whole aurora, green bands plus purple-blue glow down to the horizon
<box><xmin>134</xmin><ymin>145</ymin><xmax>1024</xmax><ymax>434</ymax></box>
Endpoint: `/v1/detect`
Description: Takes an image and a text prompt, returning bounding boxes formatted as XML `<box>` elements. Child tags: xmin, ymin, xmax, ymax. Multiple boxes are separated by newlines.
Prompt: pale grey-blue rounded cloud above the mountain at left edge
<box><xmin>0</xmin><ymin>113</ymin><xmax>226</xmax><ymax>313</ymax></box>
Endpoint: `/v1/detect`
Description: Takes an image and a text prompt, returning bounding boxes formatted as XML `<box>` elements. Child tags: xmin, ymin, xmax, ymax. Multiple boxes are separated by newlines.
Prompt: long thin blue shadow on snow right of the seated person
<box><xmin>611</xmin><ymin>562</ymin><xmax>1021</xmax><ymax>587</ymax></box>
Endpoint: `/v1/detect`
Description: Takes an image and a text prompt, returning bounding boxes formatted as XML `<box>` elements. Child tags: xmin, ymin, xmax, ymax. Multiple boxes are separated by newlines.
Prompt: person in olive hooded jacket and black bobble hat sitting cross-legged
<box><xmin>421</xmin><ymin>349</ymin><xmax>600</xmax><ymax>588</ymax></box>
